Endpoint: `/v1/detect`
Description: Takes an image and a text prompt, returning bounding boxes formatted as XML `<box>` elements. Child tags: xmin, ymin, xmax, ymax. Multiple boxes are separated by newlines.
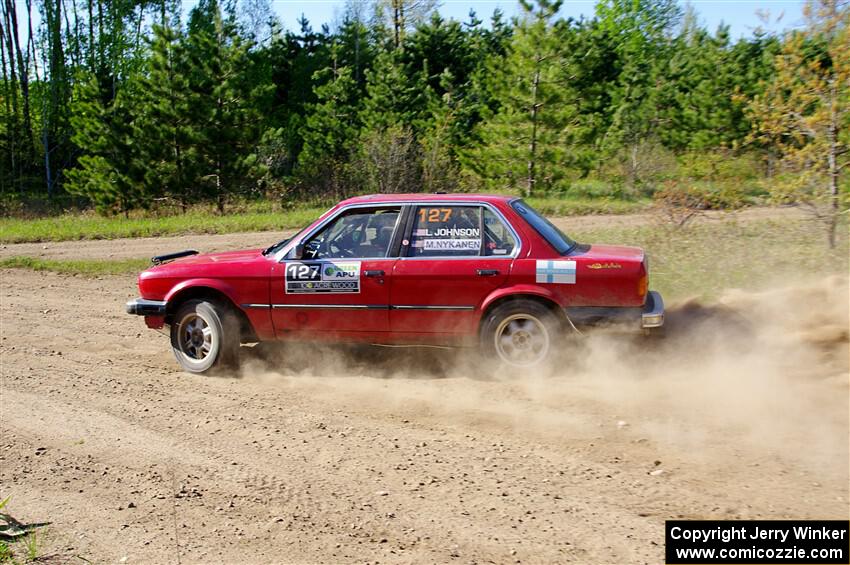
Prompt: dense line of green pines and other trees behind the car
<box><xmin>0</xmin><ymin>0</ymin><xmax>850</xmax><ymax>240</ymax></box>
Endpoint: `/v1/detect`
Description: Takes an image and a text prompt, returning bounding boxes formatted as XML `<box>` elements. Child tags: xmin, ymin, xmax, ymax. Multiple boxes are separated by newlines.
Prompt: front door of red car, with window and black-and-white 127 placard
<box><xmin>272</xmin><ymin>206</ymin><xmax>401</xmax><ymax>339</ymax></box>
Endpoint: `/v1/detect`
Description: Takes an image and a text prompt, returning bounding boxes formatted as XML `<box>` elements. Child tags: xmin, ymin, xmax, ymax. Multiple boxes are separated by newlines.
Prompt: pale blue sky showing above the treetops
<box><xmin>268</xmin><ymin>0</ymin><xmax>803</xmax><ymax>39</ymax></box>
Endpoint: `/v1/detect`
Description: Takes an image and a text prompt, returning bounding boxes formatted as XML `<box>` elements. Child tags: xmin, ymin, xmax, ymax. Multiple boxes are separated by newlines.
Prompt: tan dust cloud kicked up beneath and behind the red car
<box><xmin>242</xmin><ymin>277</ymin><xmax>850</xmax><ymax>480</ymax></box>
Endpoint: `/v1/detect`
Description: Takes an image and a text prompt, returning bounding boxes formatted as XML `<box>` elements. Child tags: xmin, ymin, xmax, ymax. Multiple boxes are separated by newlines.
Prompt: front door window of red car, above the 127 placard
<box><xmin>304</xmin><ymin>207</ymin><xmax>401</xmax><ymax>259</ymax></box>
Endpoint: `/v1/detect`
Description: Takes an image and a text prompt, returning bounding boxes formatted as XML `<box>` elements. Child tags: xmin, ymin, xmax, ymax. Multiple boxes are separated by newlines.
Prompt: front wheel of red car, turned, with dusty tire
<box><xmin>171</xmin><ymin>299</ymin><xmax>240</xmax><ymax>373</ymax></box>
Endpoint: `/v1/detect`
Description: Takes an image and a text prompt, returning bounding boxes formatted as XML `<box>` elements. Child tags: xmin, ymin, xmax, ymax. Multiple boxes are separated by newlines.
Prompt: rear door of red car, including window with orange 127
<box><xmin>390</xmin><ymin>203</ymin><xmax>519</xmax><ymax>336</ymax></box>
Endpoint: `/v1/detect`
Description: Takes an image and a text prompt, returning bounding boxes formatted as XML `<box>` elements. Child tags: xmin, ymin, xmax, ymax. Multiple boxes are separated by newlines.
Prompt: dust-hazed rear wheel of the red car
<box><xmin>481</xmin><ymin>299</ymin><xmax>563</xmax><ymax>369</ymax></box>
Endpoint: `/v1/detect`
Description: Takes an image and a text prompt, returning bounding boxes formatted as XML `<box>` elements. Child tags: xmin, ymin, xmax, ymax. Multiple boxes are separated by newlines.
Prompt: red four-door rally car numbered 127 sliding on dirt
<box><xmin>127</xmin><ymin>194</ymin><xmax>664</xmax><ymax>373</ymax></box>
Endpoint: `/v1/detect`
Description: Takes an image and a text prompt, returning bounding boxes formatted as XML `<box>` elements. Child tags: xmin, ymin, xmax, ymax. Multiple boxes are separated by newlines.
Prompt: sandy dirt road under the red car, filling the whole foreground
<box><xmin>0</xmin><ymin>227</ymin><xmax>850</xmax><ymax>563</ymax></box>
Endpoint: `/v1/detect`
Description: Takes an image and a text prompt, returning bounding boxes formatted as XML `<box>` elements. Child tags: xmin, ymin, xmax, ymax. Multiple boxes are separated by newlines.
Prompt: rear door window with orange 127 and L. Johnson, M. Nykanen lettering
<box><xmin>407</xmin><ymin>205</ymin><xmax>481</xmax><ymax>257</ymax></box>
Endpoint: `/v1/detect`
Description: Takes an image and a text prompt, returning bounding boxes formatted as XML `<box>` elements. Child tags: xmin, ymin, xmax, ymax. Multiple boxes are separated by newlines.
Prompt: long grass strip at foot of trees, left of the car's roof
<box><xmin>0</xmin><ymin>207</ymin><xmax>327</xmax><ymax>243</ymax></box>
